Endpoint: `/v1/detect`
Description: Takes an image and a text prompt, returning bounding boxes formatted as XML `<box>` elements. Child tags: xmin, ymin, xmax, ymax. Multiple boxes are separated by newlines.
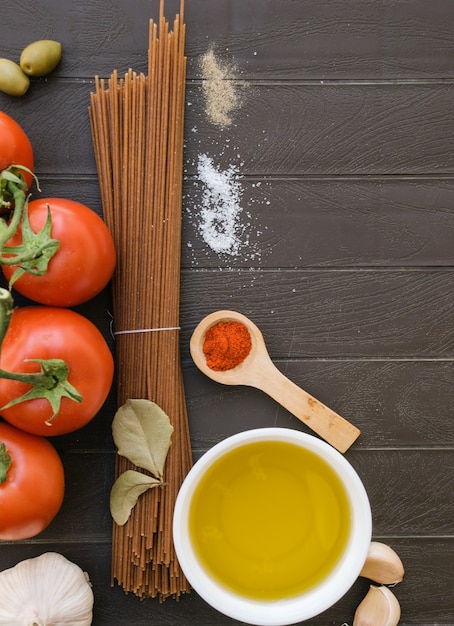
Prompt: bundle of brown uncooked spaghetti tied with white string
<box><xmin>89</xmin><ymin>0</ymin><xmax>192</xmax><ymax>601</ymax></box>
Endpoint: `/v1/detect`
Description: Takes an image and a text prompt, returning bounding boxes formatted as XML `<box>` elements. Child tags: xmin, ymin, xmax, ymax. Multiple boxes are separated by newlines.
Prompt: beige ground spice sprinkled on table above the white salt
<box><xmin>200</xmin><ymin>49</ymin><xmax>245</xmax><ymax>129</ymax></box>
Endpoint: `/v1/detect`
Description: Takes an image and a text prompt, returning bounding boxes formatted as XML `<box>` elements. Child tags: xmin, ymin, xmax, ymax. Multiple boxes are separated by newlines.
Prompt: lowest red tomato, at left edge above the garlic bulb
<box><xmin>0</xmin><ymin>421</ymin><xmax>65</xmax><ymax>541</ymax></box>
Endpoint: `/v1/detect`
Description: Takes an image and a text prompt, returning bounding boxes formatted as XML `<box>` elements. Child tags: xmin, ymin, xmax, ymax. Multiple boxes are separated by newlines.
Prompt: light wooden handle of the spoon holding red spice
<box><xmin>254</xmin><ymin>361</ymin><xmax>360</xmax><ymax>452</ymax></box>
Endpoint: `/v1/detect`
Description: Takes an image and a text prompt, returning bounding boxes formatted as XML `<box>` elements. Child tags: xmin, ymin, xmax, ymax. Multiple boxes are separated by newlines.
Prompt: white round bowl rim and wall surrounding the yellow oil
<box><xmin>173</xmin><ymin>428</ymin><xmax>372</xmax><ymax>626</ymax></box>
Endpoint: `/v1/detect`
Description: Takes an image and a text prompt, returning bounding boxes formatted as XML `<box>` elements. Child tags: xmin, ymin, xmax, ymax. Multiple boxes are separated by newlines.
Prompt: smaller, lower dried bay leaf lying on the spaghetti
<box><xmin>110</xmin><ymin>470</ymin><xmax>162</xmax><ymax>526</ymax></box>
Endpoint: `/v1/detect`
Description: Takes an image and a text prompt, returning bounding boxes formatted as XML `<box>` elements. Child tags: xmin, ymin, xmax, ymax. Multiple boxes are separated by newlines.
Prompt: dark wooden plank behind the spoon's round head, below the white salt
<box><xmin>181</xmin><ymin>268</ymin><xmax>454</xmax><ymax>359</ymax></box>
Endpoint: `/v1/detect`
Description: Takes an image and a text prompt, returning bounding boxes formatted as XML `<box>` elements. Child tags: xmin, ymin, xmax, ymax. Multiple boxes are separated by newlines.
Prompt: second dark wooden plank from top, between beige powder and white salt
<box><xmin>0</xmin><ymin>79</ymin><xmax>454</xmax><ymax>177</ymax></box>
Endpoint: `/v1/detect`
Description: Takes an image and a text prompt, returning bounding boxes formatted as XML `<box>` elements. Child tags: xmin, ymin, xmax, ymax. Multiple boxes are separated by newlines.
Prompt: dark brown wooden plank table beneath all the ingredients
<box><xmin>0</xmin><ymin>0</ymin><xmax>454</xmax><ymax>626</ymax></box>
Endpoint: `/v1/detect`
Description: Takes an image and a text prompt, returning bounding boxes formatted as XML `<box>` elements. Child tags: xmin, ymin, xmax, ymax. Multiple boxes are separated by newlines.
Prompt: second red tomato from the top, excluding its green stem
<box><xmin>2</xmin><ymin>198</ymin><xmax>116</xmax><ymax>306</ymax></box>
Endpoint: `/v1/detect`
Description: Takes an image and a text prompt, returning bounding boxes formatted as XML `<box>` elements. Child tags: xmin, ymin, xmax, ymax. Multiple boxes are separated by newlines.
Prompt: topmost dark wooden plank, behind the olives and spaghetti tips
<box><xmin>2</xmin><ymin>0</ymin><xmax>454</xmax><ymax>80</ymax></box>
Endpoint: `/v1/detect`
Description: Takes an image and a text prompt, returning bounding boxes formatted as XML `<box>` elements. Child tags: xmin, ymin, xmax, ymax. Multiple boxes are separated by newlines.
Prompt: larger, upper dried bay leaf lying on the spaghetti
<box><xmin>112</xmin><ymin>399</ymin><xmax>173</xmax><ymax>480</ymax></box>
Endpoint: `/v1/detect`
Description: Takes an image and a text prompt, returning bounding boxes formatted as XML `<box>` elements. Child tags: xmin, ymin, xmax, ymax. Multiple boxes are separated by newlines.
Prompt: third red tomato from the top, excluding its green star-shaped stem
<box><xmin>0</xmin><ymin>306</ymin><xmax>114</xmax><ymax>436</ymax></box>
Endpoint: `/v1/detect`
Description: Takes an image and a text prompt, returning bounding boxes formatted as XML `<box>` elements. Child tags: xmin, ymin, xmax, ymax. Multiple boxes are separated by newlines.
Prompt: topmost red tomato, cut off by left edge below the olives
<box><xmin>0</xmin><ymin>111</ymin><xmax>34</xmax><ymax>187</ymax></box>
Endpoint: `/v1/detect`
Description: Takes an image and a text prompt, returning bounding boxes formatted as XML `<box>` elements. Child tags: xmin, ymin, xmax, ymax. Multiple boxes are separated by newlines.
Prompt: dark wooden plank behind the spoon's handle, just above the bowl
<box><xmin>185</xmin><ymin>359</ymin><xmax>454</xmax><ymax>448</ymax></box>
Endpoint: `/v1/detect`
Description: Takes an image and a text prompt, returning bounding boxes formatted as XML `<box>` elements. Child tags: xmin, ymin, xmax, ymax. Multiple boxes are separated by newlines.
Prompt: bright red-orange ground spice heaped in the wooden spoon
<box><xmin>203</xmin><ymin>321</ymin><xmax>252</xmax><ymax>372</ymax></box>
